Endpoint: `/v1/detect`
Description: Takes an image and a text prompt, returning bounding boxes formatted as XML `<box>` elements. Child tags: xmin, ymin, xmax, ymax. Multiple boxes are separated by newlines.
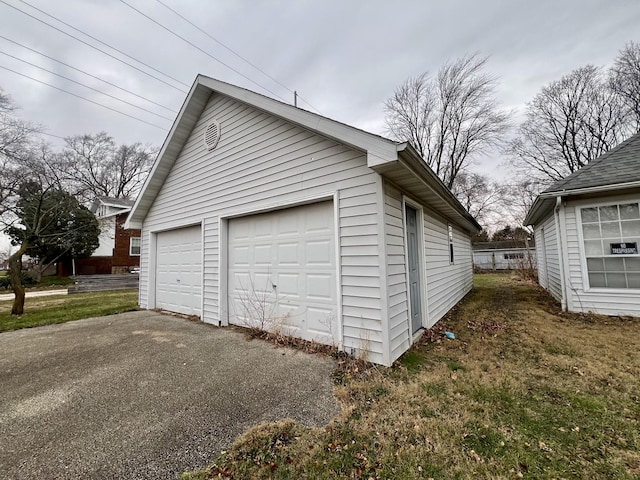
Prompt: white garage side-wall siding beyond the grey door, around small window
<box><xmin>424</xmin><ymin>210</ymin><xmax>473</xmax><ymax>327</ymax></box>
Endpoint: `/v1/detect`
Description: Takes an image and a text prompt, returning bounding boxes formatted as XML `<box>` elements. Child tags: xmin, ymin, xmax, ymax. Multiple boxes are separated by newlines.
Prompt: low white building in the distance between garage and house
<box><xmin>473</xmin><ymin>240</ymin><xmax>537</xmax><ymax>270</ymax></box>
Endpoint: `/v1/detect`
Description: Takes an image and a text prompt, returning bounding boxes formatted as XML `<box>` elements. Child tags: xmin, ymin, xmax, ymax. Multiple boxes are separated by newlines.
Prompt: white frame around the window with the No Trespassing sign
<box><xmin>576</xmin><ymin>195</ymin><xmax>640</xmax><ymax>295</ymax></box>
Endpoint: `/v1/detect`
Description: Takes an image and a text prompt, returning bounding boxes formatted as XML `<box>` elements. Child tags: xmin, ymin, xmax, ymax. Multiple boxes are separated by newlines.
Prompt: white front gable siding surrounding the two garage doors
<box><xmin>140</xmin><ymin>94</ymin><xmax>386</xmax><ymax>363</ymax></box>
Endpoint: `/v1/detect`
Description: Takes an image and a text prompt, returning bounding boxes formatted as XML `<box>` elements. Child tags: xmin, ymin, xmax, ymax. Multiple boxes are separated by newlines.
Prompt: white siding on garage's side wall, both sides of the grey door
<box><xmin>384</xmin><ymin>182</ymin><xmax>473</xmax><ymax>361</ymax></box>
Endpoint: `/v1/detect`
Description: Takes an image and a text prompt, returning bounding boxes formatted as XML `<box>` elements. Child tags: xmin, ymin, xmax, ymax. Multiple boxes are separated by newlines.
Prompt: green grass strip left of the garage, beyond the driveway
<box><xmin>0</xmin><ymin>290</ymin><xmax>138</xmax><ymax>332</ymax></box>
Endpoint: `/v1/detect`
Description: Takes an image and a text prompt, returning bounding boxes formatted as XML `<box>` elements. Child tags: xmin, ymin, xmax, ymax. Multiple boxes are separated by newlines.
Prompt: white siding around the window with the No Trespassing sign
<box><xmin>565</xmin><ymin>195</ymin><xmax>640</xmax><ymax>316</ymax></box>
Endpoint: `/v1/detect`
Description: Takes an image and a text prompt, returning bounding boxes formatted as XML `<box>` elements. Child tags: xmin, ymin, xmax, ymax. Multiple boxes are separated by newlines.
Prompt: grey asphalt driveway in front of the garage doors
<box><xmin>0</xmin><ymin>311</ymin><xmax>339</xmax><ymax>479</ymax></box>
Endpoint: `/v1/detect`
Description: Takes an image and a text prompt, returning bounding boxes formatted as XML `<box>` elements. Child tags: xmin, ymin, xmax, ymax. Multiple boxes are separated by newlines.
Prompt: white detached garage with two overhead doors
<box><xmin>126</xmin><ymin>76</ymin><xmax>480</xmax><ymax>365</ymax></box>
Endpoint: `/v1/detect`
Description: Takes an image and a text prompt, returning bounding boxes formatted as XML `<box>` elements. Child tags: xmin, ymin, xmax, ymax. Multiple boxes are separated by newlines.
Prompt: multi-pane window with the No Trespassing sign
<box><xmin>580</xmin><ymin>202</ymin><xmax>640</xmax><ymax>289</ymax></box>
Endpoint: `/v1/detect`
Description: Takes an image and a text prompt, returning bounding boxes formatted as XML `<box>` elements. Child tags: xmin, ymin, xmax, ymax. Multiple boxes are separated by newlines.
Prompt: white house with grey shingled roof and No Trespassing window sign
<box><xmin>525</xmin><ymin>134</ymin><xmax>640</xmax><ymax>316</ymax></box>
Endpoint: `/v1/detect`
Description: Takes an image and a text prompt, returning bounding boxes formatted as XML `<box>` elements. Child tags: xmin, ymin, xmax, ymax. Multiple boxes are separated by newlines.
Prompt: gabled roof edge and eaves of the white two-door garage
<box><xmin>125</xmin><ymin>75</ymin><xmax>481</xmax><ymax>231</ymax></box>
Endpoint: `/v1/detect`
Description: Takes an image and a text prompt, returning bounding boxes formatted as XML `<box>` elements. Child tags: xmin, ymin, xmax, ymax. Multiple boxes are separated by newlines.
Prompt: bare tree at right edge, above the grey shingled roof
<box><xmin>611</xmin><ymin>42</ymin><xmax>640</xmax><ymax>132</ymax></box>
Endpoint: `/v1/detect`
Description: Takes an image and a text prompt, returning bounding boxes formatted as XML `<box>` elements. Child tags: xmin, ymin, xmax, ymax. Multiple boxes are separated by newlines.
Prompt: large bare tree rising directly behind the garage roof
<box><xmin>385</xmin><ymin>54</ymin><xmax>509</xmax><ymax>188</ymax></box>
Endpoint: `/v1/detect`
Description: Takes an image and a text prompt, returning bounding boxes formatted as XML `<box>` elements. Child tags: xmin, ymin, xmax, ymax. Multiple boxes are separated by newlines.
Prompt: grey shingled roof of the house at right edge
<box><xmin>524</xmin><ymin>133</ymin><xmax>640</xmax><ymax>225</ymax></box>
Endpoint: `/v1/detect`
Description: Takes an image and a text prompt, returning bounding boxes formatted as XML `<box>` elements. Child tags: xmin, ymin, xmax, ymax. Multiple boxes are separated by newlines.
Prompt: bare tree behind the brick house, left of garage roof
<box><xmin>56</xmin><ymin>132</ymin><xmax>156</xmax><ymax>203</ymax></box>
